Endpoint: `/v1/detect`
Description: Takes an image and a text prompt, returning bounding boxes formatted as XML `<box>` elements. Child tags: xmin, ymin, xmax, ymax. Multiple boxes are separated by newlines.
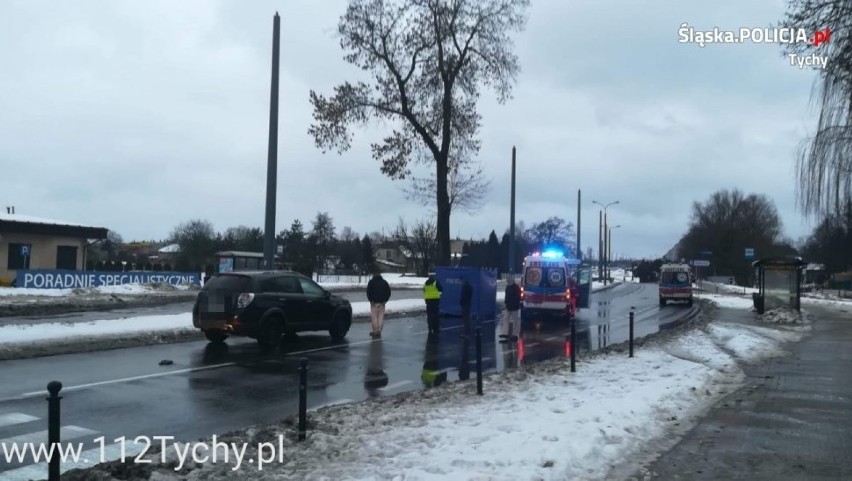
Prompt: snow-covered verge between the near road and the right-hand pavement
<box><xmin>63</xmin><ymin>288</ymin><xmax>802</xmax><ymax>480</ymax></box>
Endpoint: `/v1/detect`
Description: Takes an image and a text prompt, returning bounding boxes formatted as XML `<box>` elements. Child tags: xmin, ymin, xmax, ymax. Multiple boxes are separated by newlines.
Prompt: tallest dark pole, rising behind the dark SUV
<box><xmin>263</xmin><ymin>12</ymin><xmax>281</xmax><ymax>270</ymax></box>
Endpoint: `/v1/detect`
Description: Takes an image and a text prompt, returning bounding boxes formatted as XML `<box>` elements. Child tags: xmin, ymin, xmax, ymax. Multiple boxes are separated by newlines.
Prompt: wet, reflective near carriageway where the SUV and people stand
<box><xmin>0</xmin><ymin>284</ymin><xmax>690</xmax><ymax>474</ymax></box>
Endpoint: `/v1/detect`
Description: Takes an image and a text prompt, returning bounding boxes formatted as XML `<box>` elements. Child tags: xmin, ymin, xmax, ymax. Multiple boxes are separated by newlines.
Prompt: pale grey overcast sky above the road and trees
<box><xmin>0</xmin><ymin>0</ymin><xmax>816</xmax><ymax>256</ymax></box>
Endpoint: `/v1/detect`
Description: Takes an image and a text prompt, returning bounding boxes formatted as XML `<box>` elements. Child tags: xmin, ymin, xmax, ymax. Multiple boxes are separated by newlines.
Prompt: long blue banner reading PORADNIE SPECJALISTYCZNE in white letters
<box><xmin>15</xmin><ymin>269</ymin><xmax>201</xmax><ymax>289</ymax></box>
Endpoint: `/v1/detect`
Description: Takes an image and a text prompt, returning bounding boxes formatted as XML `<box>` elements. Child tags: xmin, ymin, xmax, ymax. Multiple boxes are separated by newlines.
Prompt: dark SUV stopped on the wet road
<box><xmin>192</xmin><ymin>271</ymin><xmax>352</xmax><ymax>347</ymax></box>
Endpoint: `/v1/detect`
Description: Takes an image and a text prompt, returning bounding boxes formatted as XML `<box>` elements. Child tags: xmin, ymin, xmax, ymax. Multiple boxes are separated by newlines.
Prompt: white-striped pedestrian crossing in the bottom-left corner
<box><xmin>0</xmin><ymin>412</ymin><xmax>144</xmax><ymax>481</ymax></box>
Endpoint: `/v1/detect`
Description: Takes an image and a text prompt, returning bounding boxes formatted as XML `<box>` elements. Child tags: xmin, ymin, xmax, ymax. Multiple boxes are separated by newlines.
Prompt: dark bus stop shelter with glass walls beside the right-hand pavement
<box><xmin>751</xmin><ymin>257</ymin><xmax>805</xmax><ymax>314</ymax></box>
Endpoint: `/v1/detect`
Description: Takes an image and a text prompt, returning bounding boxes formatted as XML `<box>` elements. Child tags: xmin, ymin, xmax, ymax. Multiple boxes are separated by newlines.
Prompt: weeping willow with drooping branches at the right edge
<box><xmin>781</xmin><ymin>0</ymin><xmax>852</xmax><ymax>218</ymax></box>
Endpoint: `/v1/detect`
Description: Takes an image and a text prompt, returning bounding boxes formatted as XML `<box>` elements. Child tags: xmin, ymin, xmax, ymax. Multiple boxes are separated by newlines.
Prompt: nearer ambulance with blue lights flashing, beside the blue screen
<box><xmin>520</xmin><ymin>250</ymin><xmax>580</xmax><ymax>321</ymax></box>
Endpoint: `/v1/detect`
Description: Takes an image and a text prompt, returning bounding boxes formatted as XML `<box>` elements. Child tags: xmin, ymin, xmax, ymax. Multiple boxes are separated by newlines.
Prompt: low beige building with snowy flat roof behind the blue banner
<box><xmin>0</xmin><ymin>208</ymin><xmax>107</xmax><ymax>284</ymax></box>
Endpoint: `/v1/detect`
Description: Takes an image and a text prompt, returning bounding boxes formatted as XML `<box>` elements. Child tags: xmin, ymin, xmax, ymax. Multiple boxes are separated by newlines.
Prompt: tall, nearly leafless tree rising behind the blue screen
<box><xmin>308</xmin><ymin>0</ymin><xmax>529</xmax><ymax>264</ymax></box>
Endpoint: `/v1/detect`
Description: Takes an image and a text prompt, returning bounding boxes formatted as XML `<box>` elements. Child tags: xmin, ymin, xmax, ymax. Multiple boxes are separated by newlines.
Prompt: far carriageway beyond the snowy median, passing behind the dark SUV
<box><xmin>0</xmin><ymin>288</ymin><xmax>422</xmax><ymax>326</ymax></box>
